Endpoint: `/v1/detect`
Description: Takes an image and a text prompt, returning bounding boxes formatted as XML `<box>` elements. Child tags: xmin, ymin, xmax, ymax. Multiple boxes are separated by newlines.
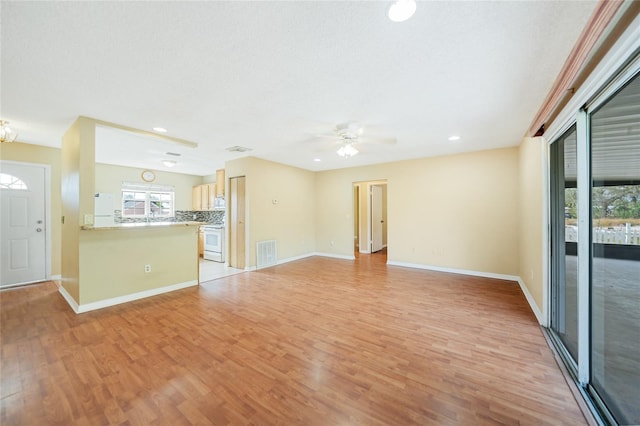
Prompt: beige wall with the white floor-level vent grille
<box><xmin>225</xmin><ymin>157</ymin><xmax>318</xmax><ymax>267</ymax></box>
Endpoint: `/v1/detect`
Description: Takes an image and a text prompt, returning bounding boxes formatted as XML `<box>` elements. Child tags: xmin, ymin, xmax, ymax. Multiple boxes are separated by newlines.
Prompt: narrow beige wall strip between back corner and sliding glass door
<box><xmin>518</xmin><ymin>138</ymin><xmax>547</xmax><ymax>313</ymax></box>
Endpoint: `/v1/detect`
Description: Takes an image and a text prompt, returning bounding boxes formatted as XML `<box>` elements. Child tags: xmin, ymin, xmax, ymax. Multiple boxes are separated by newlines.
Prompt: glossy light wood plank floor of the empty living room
<box><xmin>0</xmin><ymin>254</ymin><xmax>585</xmax><ymax>426</ymax></box>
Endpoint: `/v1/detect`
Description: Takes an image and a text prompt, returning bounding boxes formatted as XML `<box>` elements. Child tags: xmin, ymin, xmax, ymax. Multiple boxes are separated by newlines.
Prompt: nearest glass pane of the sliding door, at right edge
<box><xmin>590</xmin><ymin>70</ymin><xmax>640</xmax><ymax>424</ymax></box>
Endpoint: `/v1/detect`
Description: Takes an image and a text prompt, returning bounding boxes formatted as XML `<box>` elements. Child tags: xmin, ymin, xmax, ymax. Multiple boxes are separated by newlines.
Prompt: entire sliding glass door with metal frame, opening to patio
<box><xmin>550</xmin><ymin>65</ymin><xmax>640</xmax><ymax>425</ymax></box>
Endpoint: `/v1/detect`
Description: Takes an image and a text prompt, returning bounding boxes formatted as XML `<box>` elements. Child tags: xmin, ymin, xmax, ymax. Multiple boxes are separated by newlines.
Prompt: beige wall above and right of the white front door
<box><xmin>0</xmin><ymin>142</ymin><xmax>62</xmax><ymax>275</ymax></box>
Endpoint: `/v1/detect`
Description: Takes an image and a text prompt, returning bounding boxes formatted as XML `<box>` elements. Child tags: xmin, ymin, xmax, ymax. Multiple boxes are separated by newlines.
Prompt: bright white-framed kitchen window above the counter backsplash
<box><xmin>122</xmin><ymin>184</ymin><xmax>175</xmax><ymax>218</ymax></box>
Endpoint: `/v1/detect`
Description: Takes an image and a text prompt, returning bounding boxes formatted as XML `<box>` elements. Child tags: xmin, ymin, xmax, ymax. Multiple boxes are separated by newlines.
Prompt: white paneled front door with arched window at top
<box><xmin>0</xmin><ymin>162</ymin><xmax>46</xmax><ymax>287</ymax></box>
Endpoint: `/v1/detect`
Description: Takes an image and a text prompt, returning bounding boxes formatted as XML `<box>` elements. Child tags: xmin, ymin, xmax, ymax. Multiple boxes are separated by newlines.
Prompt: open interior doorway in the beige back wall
<box><xmin>353</xmin><ymin>180</ymin><xmax>387</xmax><ymax>257</ymax></box>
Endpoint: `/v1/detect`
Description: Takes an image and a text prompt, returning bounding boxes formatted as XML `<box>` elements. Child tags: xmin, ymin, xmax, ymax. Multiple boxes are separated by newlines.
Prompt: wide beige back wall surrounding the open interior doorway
<box><xmin>316</xmin><ymin>148</ymin><xmax>519</xmax><ymax>275</ymax></box>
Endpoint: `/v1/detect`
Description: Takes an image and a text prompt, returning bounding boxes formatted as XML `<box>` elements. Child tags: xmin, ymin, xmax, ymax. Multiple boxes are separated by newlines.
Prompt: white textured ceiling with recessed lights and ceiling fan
<box><xmin>0</xmin><ymin>0</ymin><xmax>596</xmax><ymax>175</ymax></box>
